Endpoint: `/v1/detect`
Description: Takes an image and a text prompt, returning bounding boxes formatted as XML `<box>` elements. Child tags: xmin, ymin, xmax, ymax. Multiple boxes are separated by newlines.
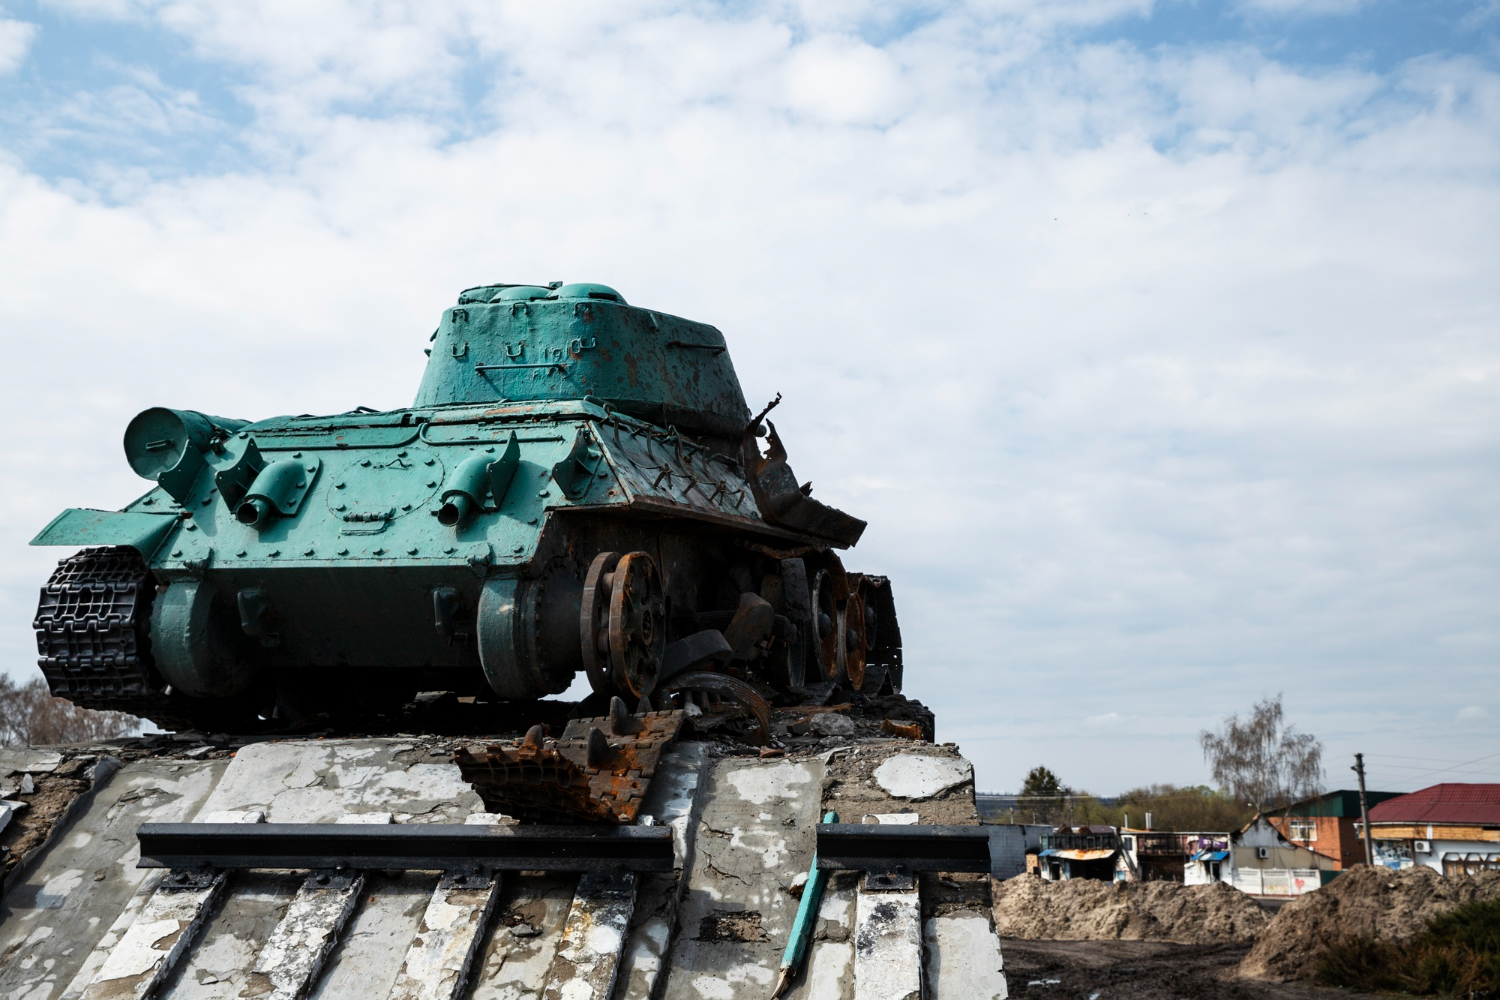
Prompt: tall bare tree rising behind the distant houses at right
<box><xmin>1199</xmin><ymin>693</ymin><xmax>1323</xmax><ymax>813</ymax></box>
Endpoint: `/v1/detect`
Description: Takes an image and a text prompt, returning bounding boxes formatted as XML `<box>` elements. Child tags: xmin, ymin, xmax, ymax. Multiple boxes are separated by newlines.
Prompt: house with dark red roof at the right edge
<box><xmin>1370</xmin><ymin>783</ymin><xmax>1500</xmax><ymax>876</ymax></box>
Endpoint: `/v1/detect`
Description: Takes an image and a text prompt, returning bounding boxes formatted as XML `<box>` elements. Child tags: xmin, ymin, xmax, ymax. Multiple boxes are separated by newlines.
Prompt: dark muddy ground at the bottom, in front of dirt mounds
<box><xmin>1001</xmin><ymin>939</ymin><xmax>1389</xmax><ymax>1000</ymax></box>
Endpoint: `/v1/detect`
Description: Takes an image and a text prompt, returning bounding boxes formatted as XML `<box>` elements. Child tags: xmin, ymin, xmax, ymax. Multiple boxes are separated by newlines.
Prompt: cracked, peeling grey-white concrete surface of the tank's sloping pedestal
<box><xmin>0</xmin><ymin>739</ymin><xmax>1005</xmax><ymax>1000</ymax></box>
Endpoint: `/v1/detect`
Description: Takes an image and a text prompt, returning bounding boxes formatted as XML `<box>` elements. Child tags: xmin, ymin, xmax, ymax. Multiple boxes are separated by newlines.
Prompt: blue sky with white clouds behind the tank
<box><xmin>0</xmin><ymin>0</ymin><xmax>1500</xmax><ymax>795</ymax></box>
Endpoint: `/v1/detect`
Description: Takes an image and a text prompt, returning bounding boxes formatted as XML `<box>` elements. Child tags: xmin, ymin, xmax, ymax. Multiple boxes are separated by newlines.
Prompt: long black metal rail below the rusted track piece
<box><xmin>137</xmin><ymin>823</ymin><xmax>674</xmax><ymax>871</ymax></box>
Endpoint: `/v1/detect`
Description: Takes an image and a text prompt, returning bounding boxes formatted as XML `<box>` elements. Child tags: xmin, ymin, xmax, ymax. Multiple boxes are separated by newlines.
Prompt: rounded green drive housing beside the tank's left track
<box><xmin>152</xmin><ymin>580</ymin><xmax>255</xmax><ymax>697</ymax></box>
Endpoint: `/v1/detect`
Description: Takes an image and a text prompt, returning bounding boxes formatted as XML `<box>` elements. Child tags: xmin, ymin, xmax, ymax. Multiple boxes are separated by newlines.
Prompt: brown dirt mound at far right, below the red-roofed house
<box><xmin>1239</xmin><ymin>865</ymin><xmax>1500</xmax><ymax>982</ymax></box>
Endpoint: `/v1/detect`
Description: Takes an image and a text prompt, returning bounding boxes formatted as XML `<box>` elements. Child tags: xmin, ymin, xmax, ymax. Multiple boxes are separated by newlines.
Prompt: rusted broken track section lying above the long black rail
<box><xmin>453</xmin><ymin>697</ymin><xmax>684</xmax><ymax>823</ymax></box>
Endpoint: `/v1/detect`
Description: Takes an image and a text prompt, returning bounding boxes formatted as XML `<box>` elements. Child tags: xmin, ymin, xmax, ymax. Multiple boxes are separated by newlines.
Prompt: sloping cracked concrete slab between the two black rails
<box><xmin>663</xmin><ymin>757</ymin><xmax>824</xmax><ymax>1000</ymax></box>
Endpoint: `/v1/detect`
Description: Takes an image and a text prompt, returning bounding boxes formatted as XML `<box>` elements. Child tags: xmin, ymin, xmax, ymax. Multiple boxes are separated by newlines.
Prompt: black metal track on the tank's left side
<box><xmin>32</xmin><ymin>546</ymin><xmax>192</xmax><ymax>729</ymax></box>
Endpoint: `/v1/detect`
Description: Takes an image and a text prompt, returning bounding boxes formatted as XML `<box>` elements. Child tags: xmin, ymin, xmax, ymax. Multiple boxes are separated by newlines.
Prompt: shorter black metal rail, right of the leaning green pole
<box><xmin>818</xmin><ymin>823</ymin><xmax>990</xmax><ymax>871</ymax></box>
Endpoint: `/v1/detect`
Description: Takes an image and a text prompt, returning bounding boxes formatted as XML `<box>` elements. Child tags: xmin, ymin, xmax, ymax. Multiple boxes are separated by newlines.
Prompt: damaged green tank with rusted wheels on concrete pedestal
<box><xmin>32</xmin><ymin>283</ymin><xmax>902</xmax><ymax>732</ymax></box>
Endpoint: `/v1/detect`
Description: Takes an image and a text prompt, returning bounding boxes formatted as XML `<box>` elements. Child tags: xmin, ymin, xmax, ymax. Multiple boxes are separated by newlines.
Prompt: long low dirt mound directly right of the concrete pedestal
<box><xmin>995</xmin><ymin>876</ymin><xmax>1269</xmax><ymax>945</ymax></box>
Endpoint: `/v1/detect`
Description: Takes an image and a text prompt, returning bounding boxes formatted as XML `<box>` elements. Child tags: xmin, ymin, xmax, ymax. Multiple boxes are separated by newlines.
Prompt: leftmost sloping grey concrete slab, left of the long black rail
<box><xmin>0</xmin><ymin>760</ymin><xmax>225</xmax><ymax>1000</ymax></box>
